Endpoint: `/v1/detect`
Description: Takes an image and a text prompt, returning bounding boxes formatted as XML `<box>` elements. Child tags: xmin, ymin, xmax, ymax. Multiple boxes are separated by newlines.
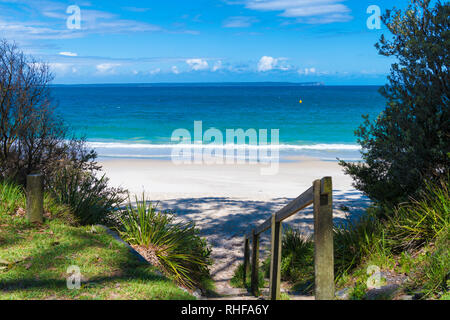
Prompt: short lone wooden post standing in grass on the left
<box><xmin>27</xmin><ymin>174</ymin><xmax>44</xmax><ymax>223</ymax></box>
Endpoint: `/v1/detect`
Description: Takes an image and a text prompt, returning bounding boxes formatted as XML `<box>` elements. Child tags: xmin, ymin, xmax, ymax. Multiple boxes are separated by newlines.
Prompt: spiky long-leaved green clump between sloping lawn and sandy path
<box><xmin>118</xmin><ymin>195</ymin><xmax>212</xmax><ymax>288</ymax></box>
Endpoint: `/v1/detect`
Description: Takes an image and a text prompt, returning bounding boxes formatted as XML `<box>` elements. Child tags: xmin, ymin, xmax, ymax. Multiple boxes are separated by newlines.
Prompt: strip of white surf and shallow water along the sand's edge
<box><xmin>87</xmin><ymin>140</ymin><xmax>362</xmax><ymax>162</ymax></box>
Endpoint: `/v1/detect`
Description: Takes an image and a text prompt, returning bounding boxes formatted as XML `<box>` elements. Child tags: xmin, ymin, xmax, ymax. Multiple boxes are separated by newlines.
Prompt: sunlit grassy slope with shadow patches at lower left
<box><xmin>0</xmin><ymin>210</ymin><xmax>194</xmax><ymax>299</ymax></box>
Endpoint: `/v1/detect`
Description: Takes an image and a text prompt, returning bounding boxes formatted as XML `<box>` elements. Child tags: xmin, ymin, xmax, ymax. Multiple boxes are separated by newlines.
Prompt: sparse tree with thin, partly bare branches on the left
<box><xmin>0</xmin><ymin>40</ymin><xmax>97</xmax><ymax>184</ymax></box>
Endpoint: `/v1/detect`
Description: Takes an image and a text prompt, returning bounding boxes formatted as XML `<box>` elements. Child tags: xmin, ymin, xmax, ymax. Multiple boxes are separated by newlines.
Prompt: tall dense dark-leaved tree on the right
<box><xmin>340</xmin><ymin>0</ymin><xmax>450</xmax><ymax>205</ymax></box>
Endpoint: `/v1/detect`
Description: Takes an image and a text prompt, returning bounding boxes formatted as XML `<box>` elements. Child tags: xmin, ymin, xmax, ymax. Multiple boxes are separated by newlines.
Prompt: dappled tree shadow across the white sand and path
<box><xmin>153</xmin><ymin>190</ymin><xmax>370</xmax><ymax>294</ymax></box>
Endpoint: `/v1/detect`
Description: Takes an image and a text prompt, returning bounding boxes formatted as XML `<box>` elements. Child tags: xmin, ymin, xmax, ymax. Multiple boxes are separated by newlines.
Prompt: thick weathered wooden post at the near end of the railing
<box><xmin>313</xmin><ymin>177</ymin><xmax>335</xmax><ymax>300</ymax></box>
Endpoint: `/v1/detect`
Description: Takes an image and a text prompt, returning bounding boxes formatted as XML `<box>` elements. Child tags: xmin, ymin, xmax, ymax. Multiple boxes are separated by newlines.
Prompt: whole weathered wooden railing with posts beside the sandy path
<box><xmin>243</xmin><ymin>177</ymin><xmax>334</xmax><ymax>300</ymax></box>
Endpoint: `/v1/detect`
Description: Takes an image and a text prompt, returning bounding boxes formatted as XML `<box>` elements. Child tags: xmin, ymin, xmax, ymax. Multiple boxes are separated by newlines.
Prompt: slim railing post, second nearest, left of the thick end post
<box><xmin>269</xmin><ymin>213</ymin><xmax>282</xmax><ymax>300</ymax></box>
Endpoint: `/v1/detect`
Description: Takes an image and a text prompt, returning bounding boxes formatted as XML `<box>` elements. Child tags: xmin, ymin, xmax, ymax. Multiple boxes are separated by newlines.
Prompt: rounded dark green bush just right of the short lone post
<box><xmin>49</xmin><ymin>166</ymin><xmax>126</xmax><ymax>225</ymax></box>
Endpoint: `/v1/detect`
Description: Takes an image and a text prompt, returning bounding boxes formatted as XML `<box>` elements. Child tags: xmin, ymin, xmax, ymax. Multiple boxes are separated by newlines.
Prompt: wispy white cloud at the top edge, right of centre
<box><xmin>235</xmin><ymin>0</ymin><xmax>352</xmax><ymax>24</ymax></box>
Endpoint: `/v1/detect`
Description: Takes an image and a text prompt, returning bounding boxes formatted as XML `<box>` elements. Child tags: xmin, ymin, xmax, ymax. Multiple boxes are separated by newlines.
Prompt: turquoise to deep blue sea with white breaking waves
<box><xmin>52</xmin><ymin>84</ymin><xmax>385</xmax><ymax>160</ymax></box>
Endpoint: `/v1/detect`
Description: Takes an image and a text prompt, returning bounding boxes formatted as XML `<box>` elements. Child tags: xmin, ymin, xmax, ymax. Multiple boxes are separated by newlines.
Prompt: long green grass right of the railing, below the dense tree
<box><xmin>335</xmin><ymin>179</ymin><xmax>450</xmax><ymax>299</ymax></box>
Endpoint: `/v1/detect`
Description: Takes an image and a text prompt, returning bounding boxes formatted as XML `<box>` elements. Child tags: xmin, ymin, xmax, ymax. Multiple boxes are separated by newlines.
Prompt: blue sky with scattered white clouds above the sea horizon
<box><xmin>0</xmin><ymin>0</ymin><xmax>414</xmax><ymax>85</ymax></box>
